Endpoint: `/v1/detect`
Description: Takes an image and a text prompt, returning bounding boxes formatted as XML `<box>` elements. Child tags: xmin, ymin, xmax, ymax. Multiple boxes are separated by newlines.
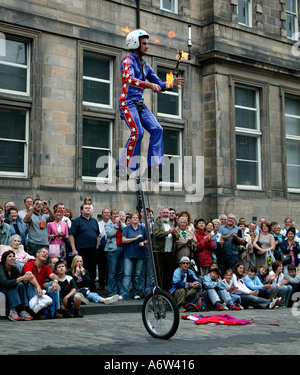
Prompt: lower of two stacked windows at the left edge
<box><xmin>0</xmin><ymin>106</ymin><xmax>29</xmax><ymax>177</ymax></box>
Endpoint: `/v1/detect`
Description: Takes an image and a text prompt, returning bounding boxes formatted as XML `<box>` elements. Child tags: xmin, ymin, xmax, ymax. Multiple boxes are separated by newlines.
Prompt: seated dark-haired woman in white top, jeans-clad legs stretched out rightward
<box><xmin>232</xmin><ymin>263</ymin><xmax>280</xmax><ymax>309</ymax></box>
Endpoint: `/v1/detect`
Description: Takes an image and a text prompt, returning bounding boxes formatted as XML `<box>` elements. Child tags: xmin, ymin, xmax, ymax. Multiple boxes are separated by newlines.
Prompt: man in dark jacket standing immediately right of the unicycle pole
<box><xmin>152</xmin><ymin>207</ymin><xmax>179</xmax><ymax>291</ymax></box>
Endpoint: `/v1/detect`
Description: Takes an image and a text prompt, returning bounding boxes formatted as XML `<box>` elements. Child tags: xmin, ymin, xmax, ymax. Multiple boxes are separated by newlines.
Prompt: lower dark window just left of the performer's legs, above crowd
<box><xmin>82</xmin><ymin>117</ymin><xmax>112</xmax><ymax>180</ymax></box>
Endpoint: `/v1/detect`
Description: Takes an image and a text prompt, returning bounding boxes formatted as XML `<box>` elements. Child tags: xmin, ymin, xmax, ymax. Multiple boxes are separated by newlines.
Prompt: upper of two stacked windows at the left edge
<box><xmin>0</xmin><ymin>38</ymin><xmax>30</xmax><ymax>95</ymax></box>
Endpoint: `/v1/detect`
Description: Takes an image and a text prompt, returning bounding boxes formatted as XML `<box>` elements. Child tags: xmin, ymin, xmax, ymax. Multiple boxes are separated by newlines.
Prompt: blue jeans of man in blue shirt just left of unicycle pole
<box><xmin>121</xmin><ymin>258</ymin><xmax>144</xmax><ymax>299</ymax></box>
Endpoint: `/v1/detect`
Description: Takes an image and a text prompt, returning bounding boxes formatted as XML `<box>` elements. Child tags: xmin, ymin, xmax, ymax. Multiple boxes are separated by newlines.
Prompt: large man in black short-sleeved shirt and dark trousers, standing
<box><xmin>69</xmin><ymin>204</ymin><xmax>100</xmax><ymax>292</ymax></box>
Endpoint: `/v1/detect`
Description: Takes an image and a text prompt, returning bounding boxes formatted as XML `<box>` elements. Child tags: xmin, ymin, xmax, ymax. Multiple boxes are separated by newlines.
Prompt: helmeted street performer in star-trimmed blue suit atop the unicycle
<box><xmin>117</xmin><ymin>29</ymin><xmax>184</xmax><ymax>180</ymax></box>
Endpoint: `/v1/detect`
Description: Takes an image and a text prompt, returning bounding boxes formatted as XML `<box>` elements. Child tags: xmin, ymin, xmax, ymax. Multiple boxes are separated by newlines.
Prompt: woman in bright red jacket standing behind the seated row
<box><xmin>195</xmin><ymin>219</ymin><xmax>215</xmax><ymax>276</ymax></box>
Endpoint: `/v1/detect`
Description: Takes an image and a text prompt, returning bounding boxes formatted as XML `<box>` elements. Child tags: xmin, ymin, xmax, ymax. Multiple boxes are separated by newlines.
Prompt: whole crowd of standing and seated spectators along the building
<box><xmin>0</xmin><ymin>196</ymin><xmax>300</xmax><ymax>321</ymax></box>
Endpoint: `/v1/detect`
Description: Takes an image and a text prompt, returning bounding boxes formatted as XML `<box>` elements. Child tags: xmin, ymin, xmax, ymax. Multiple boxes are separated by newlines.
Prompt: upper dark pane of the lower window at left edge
<box><xmin>0</xmin><ymin>107</ymin><xmax>26</xmax><ymax>141</ymax></box>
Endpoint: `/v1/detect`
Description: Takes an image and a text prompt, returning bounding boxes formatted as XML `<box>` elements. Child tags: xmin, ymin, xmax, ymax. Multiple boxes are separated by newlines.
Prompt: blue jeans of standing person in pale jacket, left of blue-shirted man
<box><xmin>106</xmin><ymin>247</ymin><xmax>124</xmax><ymax>297</ymax></box>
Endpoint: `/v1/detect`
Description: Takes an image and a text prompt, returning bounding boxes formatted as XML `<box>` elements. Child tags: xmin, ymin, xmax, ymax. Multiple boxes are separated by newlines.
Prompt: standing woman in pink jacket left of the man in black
<box><xmin>47</xmin><ymin>208</ymin><xmax>69</xmax><ymax>263</ymax></box>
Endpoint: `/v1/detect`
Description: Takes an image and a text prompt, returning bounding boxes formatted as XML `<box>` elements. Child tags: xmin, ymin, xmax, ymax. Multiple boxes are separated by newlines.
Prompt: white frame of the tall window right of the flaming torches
<box><xmin>234</xmin><ymin>84</ymin><xmax>262</xmax><ymax>190</ymax></box>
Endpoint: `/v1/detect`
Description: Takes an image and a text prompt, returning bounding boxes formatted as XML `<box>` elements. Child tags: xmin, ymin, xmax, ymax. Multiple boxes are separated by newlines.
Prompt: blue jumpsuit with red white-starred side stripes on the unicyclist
<box><xmin>119</xmin><ymin>53</ymin><xmax>166</xmax><ymax>170</ymax></box>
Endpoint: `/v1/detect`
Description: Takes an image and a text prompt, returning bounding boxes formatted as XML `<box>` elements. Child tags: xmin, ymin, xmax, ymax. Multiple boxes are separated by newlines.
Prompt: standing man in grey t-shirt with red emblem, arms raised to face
<box><xmin>23</xmin><ymin>199</ymin><xmax>55</xmax><ymax>256</ymax></box>
